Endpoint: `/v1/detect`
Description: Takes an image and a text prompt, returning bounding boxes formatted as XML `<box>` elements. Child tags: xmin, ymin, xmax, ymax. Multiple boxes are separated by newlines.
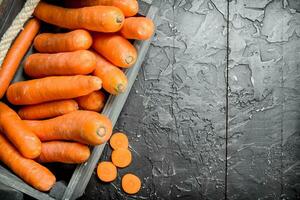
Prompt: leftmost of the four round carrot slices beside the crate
<box><xmin>97</xmin><ymin>161</ymin><xmax>117</xmax><ymax>182</ymax></box>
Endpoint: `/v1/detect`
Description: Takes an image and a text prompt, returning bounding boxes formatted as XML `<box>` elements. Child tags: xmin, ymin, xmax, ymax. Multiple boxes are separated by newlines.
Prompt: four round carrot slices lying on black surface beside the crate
<box><xmin>97</xmin><ymin>132</ymin><xmax>142</xmax><ymax>194</ymax></box>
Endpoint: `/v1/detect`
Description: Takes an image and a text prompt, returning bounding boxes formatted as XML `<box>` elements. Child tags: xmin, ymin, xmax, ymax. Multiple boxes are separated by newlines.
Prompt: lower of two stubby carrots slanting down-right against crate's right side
<box><xmin>93</xmin><ymin>53</ymin><xmax>128</xmax><ymax>95</ymax></box>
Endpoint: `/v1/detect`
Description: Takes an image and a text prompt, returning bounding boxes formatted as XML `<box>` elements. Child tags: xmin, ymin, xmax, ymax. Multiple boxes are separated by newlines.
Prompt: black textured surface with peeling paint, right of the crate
<box><xmin>82</xmin><ymin>0</ymin><xmax>300</xmax><ymax>199</ymax></box>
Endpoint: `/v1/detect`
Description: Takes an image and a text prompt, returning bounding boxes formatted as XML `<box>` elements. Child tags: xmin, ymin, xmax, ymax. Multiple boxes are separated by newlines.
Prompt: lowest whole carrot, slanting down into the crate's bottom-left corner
<box><xmin>0</xmin><ymin>134</ymin><xmax>55</xmax><ymax>191</ymax></box>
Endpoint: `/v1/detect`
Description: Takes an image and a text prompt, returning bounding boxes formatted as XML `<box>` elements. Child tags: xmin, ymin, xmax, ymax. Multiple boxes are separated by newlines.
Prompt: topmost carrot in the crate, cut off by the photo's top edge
<box><xmin>65</xmin><ymin>0</ymin><xmax>139</xmax><ymax>17</ymax></box>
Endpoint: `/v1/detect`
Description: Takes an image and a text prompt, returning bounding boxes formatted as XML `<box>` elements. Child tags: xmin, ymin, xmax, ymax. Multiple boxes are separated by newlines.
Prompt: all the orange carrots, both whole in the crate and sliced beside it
<box><xmin>0</xmin><ymin>0</ymin><xmax>154</xmax><ymax>194</ymax></box>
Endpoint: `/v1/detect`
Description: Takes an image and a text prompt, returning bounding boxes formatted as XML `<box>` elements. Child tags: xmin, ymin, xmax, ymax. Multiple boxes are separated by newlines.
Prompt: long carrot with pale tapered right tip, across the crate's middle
<box><xmin>6</xmin><ymin>75</ymin><xmax>102</xmax><ymax>105</ymax></box>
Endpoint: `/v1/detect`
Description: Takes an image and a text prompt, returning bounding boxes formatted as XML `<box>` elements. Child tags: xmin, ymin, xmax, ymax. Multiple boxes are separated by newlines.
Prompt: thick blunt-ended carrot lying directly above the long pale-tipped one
<box><xmin>24</xmin><ymin>50</ymin><xmax>96</xmax><ymax>78</ymax></box>
